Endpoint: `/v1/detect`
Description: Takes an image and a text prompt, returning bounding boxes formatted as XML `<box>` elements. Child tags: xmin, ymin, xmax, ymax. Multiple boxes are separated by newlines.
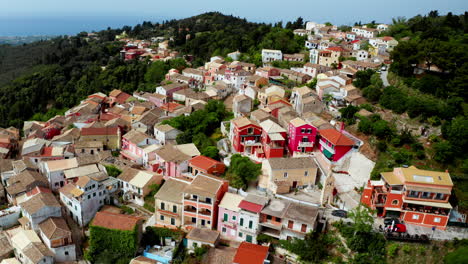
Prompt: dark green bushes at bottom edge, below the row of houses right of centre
<box><xmin>279</xmin><ymin>232</ymin><xmax>330</xmax><ymax>263</ymax></box>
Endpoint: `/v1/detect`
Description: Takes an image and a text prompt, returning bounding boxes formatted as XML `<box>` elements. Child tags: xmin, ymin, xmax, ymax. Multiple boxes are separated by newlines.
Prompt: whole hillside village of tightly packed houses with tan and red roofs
<box><xmin>0</xmin><ymin>16</ymin><xmax>468</xmax><ymax>264</ymax></box>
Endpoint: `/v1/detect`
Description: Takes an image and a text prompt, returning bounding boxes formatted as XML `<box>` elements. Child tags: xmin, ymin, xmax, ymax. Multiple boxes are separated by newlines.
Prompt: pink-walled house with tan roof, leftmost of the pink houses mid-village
<box><xmin>120</xmin><ymin>130</ymin><xmax>157</xmax><ymax>165</ymax></box>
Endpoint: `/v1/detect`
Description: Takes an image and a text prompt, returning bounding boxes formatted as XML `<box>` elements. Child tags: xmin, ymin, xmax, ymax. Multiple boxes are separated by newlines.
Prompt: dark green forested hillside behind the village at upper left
<box><xmin>0</xmin><ymin>13</ymin><xmax>304</xmax><ymax>127</ymax></box>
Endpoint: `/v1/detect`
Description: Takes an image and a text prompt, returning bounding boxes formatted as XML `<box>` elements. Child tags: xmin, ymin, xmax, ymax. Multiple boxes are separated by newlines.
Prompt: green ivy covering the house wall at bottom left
<box><xmin>85</xmin><ymin>225</ymin><xmax>138</xmax><ymax>263</ymax></box>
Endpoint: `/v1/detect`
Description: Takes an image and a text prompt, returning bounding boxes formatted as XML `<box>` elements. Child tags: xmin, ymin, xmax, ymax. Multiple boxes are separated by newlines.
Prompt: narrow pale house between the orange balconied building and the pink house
<box><xmin>218</xmin><ymin>192</ymin><xmax>244</xmax><ymax>240</ymax></box>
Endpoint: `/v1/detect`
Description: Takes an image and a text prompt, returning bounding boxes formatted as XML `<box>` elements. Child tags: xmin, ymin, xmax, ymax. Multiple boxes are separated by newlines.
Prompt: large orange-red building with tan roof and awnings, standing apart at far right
<box><xmin>361</xmin><ymin>166</ymin><xmax>453</xmax><ymax>229</ymax></box>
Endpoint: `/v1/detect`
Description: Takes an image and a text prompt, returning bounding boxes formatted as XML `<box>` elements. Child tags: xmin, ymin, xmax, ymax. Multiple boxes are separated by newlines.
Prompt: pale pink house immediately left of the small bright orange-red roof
<box><xmin>150</xmin><ymin>145</ymin><xmax>192</xmax><ymax>179</ymax></box>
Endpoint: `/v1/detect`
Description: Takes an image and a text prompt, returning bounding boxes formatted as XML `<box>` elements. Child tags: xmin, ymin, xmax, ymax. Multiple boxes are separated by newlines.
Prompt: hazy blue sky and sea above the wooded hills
<box><xmin>0</xmin><ymin>0</ymin><xmax>468</xmax><ymax>36</ymax></box>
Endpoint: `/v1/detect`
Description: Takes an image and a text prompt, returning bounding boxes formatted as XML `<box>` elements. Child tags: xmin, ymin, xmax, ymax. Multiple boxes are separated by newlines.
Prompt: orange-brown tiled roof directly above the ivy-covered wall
<box><xmin>91</xmin><ymin>211</ymin><xmax>141</xmax><ymax>230</ymax></box>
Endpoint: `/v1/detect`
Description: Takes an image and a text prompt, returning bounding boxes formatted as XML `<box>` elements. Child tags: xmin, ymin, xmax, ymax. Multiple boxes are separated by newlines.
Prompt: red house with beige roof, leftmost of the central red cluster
<box><xmin>230</xmin><ymin>117</ymin><xmax>262</xmax><ymax>155</ymax></box>
